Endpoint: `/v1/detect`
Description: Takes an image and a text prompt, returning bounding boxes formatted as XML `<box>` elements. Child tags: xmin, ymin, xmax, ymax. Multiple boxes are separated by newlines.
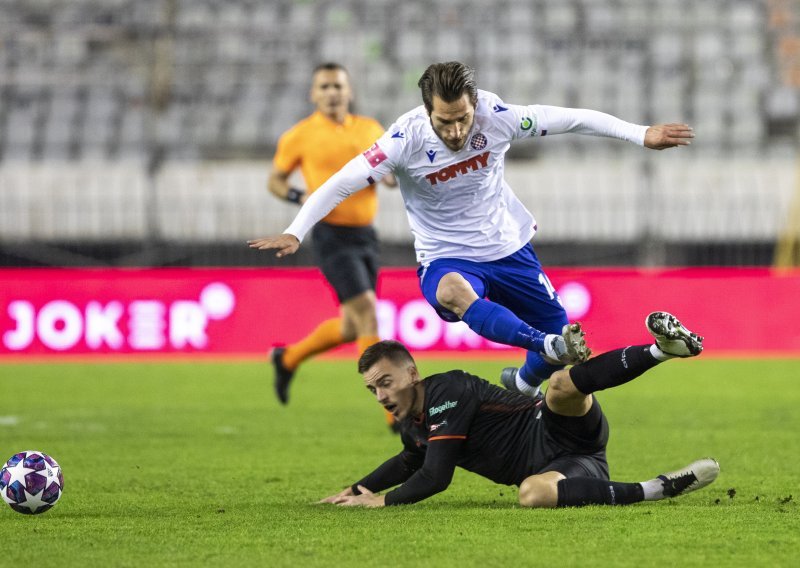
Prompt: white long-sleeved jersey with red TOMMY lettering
<box><xmin>285</xmin><ymin>90</ymin><xmax>647</xmax><ymax>264</ymax></box>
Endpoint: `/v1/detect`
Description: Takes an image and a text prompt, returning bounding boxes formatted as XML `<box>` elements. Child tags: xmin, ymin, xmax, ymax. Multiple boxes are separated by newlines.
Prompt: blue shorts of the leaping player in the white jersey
<box><xmin>417</xmin><ymin>243</ymin><xmax>568</xmax><ymax>334</ymax></box>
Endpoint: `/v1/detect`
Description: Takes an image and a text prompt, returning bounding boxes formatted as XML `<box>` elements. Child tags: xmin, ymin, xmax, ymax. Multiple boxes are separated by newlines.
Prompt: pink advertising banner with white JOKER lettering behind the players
<box><xmin>0</xmin><ymin>268</ymin><xmax>800</xmax><ymax>360</ymax></box>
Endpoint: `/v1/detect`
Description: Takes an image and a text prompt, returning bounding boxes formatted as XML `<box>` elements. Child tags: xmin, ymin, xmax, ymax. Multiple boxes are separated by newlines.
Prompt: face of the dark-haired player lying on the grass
<box><xmin>364</xmin><ymin>359</ymin><xmax>422</xmax><ymax>420</ymax></box>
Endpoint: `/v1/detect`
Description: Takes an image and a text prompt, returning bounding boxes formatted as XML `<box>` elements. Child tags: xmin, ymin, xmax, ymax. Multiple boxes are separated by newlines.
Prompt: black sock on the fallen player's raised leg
<box><xmin>569</xmin><ymin>345</ymin><xmax>661</xmax><ymax>394</ymax></box>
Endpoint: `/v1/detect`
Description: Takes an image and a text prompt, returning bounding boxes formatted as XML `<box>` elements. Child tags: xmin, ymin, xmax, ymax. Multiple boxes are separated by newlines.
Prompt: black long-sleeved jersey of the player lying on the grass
<box><xmin>353</xmin><ymin>371</ymin><xmax>592</xmax><ymax>505</ymax></box>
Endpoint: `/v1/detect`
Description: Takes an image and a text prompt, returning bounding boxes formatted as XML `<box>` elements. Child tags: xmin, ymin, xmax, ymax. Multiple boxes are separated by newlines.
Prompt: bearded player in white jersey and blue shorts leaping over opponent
<box><xmin>248</xmin><ymin>62</ymin><xmax>694</xmax><ymax>396</ymax></box>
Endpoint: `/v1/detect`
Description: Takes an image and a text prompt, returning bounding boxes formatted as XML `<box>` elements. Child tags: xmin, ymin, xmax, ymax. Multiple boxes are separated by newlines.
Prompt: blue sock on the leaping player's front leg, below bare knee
<box><xmin>461</xmin><ymin>300</ymin><xmax>547</xmax><ymax>351</ymax></box>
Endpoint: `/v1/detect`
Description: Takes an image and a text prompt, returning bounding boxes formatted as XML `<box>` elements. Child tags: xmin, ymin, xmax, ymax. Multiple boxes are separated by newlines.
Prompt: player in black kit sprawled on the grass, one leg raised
<box><xmin>322</xmin><ymin>312</ymin><xmax>719</xmax><ymax>507</ymax></box>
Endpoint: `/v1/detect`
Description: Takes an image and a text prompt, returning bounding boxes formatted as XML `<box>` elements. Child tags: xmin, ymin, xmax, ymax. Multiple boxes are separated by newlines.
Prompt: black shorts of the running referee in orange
<box><xmin>312</xmin><ymin>223</ymin><xmax>378</xmax><ymax>303</ymax></box>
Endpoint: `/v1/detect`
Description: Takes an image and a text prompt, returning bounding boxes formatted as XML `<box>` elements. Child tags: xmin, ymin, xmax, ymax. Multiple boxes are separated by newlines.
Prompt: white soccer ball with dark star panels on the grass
<box><xmin>0</xmin><ymin>451</ymin><xmax>64</xmax><ymax>515</ymax></box>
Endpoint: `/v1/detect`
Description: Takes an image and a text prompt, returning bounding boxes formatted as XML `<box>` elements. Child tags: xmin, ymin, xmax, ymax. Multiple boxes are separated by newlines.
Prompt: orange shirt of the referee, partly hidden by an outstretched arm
<box><xmin>272</xmin><ymin>111</ymin><xmax>383</xmax><ymax>227</ymax></box>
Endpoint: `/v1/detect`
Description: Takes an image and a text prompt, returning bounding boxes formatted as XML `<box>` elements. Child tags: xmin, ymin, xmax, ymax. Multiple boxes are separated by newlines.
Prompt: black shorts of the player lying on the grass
<box><xmin>535</xmin><ymin>397</ymin><xmax>609</xmax><ymax>479</ymax></box>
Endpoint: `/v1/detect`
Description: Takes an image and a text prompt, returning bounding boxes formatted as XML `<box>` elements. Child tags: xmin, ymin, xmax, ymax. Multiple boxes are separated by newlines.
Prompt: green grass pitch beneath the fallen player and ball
<box><xmin>0</xmin><ymin>358</ymin><xmax>800</xmax><ymax>568</ymax></box>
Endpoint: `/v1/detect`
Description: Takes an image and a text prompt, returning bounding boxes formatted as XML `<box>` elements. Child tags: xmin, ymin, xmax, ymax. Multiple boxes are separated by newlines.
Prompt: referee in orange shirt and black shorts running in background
<box><xmin>269</xmin><ymin>63</ymin><xmax>396</xmax><ymax>425</ymax></box>
